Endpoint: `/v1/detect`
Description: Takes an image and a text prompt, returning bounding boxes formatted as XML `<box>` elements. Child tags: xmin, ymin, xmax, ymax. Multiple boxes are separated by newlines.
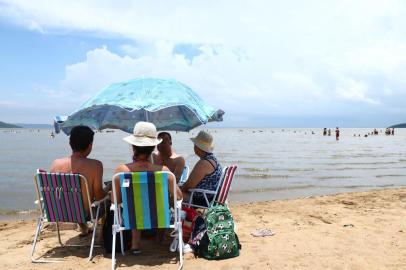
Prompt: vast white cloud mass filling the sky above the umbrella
<box><xmin>0</xmin><ymin>0</ymin><xmax>406</xmax><ymax>125</ymax></box>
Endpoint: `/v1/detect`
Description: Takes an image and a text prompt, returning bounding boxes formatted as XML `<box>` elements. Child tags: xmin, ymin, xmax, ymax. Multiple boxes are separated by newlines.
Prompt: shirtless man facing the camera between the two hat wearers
<box><xmin>153</xmin><ymin>132</ymin><xmax>185</xmax><ymax>182</ymax></box>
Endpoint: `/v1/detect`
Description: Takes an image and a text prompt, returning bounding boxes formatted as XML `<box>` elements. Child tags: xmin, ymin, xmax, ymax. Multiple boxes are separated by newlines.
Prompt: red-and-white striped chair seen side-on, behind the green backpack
<box><xmin>184</xmin><ymin>165</ymin><xmax>237</xmax><ymax>209</ymax></box>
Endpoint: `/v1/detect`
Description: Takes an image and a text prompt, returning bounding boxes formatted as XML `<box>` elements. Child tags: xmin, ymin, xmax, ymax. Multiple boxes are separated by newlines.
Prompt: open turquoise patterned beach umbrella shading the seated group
<box><xmin>55</xmin><ymin>78</ymin><xmax>224</xmax><ymax>135</ymax></box>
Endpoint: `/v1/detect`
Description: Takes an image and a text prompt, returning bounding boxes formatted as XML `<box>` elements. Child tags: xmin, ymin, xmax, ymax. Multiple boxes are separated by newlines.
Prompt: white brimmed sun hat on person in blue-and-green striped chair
<box><xmin>123</xmin><ymin>121</ymin><xmax>162</xmax><ymax>146</ymax></box>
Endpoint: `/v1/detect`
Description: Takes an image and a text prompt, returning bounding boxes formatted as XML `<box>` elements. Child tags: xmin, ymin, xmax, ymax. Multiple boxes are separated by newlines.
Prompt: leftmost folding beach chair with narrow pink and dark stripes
<box><xmin>31</xmin><ymin>170</ymin><xmax>108</xmax><ymax>262</ymax></box>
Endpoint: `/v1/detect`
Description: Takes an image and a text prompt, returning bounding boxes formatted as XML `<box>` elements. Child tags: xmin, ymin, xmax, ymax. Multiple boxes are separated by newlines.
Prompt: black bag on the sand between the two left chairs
<box><xmin>103</xmin><ymin>202</ymin><xmax>131</xmax><ymax>254</ymax></box>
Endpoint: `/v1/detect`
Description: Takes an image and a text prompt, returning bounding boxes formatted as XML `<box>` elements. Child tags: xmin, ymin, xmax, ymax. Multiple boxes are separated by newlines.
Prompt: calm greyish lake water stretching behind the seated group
<box><xmin>0</xmin><ymin>128</ymin><xmax>406</xmax><ymax>216</ymax></box>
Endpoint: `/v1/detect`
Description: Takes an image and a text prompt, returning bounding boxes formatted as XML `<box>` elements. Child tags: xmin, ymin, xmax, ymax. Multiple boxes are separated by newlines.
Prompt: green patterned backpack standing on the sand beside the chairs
<box><xmin>195</xmin><ymin>204</ymin><xmax>241</xmax><ymax>260</ymax></box>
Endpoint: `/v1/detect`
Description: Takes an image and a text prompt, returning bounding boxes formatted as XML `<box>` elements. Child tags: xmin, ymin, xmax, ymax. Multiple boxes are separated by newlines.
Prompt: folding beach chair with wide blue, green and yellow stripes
<box><xmin>112</xmin><ymin>171</ymin><xmax>183</xmax><ymax>270</ymax></box>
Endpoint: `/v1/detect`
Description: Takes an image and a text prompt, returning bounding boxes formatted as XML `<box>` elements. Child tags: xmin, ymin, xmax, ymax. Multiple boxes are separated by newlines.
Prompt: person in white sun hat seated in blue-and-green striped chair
<box><xmin>115</xmin><ymin>122</ymin><xmax>182</xmax><ymax>254</ymax></box>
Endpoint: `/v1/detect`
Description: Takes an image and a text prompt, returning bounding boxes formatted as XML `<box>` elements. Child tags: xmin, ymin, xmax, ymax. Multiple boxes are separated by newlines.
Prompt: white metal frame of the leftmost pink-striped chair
<box><xmin>30</xmin><ymin>170</ymin><xmax>108</xmax><ymax>263</ymax></box>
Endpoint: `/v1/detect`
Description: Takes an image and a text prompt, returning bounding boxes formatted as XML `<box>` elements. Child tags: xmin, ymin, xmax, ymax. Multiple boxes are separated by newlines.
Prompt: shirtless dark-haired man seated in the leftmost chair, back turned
<box><xmin>51</xmin><ymin>126</ymin><xmax>105</xmax><ymax>235</ymax></box>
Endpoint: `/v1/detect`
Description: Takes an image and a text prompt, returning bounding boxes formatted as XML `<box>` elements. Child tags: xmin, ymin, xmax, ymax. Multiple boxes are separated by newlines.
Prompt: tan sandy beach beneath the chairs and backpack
<box><xmin>0</xmin><ymin>188</ymin><xmax>406</xmax><ymax>270</ymax></box>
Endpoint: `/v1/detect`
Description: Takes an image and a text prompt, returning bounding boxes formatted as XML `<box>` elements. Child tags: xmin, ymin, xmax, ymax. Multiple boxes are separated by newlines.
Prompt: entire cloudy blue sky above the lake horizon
<box><xmin>0</xmin><ymin>0</ymin><xmax>406</xmax><ymax>127</ymax></box>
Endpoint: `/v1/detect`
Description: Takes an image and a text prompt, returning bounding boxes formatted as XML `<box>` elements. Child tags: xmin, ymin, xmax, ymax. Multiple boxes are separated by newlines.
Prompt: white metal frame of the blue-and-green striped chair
<box><xmin>111</xmin><ymin>171</ymin><xmax>183</xmax><ymax>270</ymax></box>
